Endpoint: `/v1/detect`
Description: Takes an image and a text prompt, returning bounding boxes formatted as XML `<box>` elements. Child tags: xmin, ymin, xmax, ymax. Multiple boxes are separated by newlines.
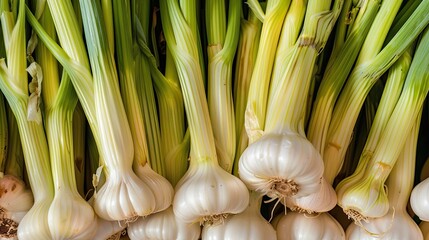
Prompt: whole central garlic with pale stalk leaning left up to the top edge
<box><xmin>160</xmin><ymin>0</ymin><xmax>249</xmax><ymax>224</ymax></box>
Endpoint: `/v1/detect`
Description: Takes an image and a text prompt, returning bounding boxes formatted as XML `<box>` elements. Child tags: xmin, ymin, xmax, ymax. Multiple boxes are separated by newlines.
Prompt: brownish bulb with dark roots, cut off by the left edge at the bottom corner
<box><xmin>0</xmin><ymin>175</ymin><xmax>33</xmax><ymax>239</ymax></box>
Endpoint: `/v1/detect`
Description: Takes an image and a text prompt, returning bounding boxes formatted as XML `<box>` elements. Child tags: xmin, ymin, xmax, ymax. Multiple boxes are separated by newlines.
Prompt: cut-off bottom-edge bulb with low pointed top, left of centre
<box><xmin>127</xmin><ymin>207</ymin><xmax>201</xmax><ymax>240</ymax></box>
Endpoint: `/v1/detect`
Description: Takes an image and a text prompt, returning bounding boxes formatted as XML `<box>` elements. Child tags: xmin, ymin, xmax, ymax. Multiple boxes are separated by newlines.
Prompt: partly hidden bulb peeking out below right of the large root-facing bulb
<box><xmin>286</xmin><ymin>178</ymin><xmax>337</xmax><ymax>213</ymax></box>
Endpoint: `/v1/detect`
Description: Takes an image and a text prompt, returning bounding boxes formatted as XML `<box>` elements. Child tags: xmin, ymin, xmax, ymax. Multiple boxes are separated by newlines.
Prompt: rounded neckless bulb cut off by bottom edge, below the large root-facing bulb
<box><xmin>276</xmin><ymin>212</ymin><xmax>346</xmax><ymax>240</ymax></box>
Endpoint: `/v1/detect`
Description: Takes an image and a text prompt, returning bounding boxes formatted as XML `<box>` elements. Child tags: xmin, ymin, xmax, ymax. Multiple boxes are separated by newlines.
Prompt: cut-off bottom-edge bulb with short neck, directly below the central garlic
<box><xmin>201</xmin><ymin>193</ymin><xmax>277</xmax><ymax>240</ymax></box>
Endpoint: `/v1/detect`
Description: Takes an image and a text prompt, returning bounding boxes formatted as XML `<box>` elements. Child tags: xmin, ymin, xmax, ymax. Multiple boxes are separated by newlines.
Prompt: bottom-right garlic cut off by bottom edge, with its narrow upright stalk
<box><xmin>346</xmin><ymin>112</ymin><xmax>423</xmax><ymax>240</ymax></box>
